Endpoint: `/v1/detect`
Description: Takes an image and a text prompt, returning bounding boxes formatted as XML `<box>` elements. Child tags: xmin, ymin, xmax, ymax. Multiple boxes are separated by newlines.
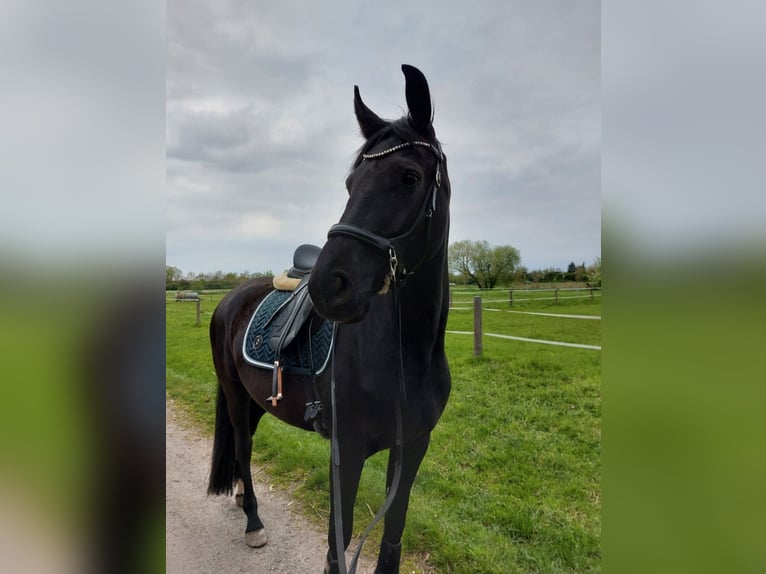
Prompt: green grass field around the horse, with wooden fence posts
<box><xmin>167</xmin><ymin>289</ymin><xmax>601</xmax><ymax>574</ymax></box>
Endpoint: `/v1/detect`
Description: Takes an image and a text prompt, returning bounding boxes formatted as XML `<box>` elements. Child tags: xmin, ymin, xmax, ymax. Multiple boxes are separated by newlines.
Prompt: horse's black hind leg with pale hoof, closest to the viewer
<box><xmin>229</xmin><ymin>396</ymin><xmax>269</xmax><ymax>548</ymax></box>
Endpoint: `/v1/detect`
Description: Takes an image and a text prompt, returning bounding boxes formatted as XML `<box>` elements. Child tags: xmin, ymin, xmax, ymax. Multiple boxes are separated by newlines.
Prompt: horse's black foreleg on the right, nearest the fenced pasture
<box><xmin>375</xmin><ymin>433</ymin><xmax>431</xmax><ymax>574</ymax></box>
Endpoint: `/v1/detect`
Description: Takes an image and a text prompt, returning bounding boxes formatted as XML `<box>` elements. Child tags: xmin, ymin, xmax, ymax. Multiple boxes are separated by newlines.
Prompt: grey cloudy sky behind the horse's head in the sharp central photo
<box><xmin>166</xmin><ymin>0</ymin><xmax>601</xmax><ymax>280</ymax></box>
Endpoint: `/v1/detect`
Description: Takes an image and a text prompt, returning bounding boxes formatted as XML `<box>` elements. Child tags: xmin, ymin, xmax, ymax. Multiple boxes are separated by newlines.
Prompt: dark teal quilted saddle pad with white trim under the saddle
<box><xmin>242</xmin><ymin>290</ymin><xmax>334</xmax><ymax>375</ymax></box>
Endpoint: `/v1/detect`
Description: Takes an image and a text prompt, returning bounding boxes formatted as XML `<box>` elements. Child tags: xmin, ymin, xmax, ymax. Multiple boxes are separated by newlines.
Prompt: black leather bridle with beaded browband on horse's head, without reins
<box><xmin>327</xmin><ymin>141</ymin><xmax>444</xmax><ymax>282</ymax></box>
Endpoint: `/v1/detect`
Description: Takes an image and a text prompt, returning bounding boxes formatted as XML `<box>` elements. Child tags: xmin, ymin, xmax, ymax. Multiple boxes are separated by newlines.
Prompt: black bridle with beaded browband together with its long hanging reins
<box><xmin>327</xmin><ymin>141</ymin><xmax>444</xmax><ymax>574</ymax></box>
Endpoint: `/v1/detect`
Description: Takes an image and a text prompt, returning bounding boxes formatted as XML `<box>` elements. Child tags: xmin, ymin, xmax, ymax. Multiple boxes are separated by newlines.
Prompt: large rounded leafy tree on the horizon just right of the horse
<box><xmin>448</xmin><ymin>239</ymin><xmax>521</xmax><ymax>289</ymax></box>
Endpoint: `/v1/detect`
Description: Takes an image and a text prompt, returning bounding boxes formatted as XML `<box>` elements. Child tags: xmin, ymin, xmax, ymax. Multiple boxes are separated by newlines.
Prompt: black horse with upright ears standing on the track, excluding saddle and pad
<box><xmin>208</xmin><ymin>65</ymin><xmax>450</xmax><ymax>573</ymax></box>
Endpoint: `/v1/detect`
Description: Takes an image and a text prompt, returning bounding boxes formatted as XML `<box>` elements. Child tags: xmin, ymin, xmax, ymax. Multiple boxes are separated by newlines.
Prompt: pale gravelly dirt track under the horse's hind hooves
<box><xmin>165</xmin><ymin>399</ymin><xmax>374</xmax><ymax>574</ymax></box>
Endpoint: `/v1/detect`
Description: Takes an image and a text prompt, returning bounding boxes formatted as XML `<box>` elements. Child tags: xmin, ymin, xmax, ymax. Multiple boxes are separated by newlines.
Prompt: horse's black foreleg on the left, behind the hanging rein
<box><xmin>324</xmin><ymin>448</ymin><xmax>364</xmax><ymax>574</ymax></box>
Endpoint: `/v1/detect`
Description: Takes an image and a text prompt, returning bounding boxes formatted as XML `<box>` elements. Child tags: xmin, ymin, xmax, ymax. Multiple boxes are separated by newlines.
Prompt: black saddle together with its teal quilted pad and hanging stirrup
<box><xmin>242</xmin><ymin>244</ymin><xmax>334</xmax><ymax>420</ymax></box>
